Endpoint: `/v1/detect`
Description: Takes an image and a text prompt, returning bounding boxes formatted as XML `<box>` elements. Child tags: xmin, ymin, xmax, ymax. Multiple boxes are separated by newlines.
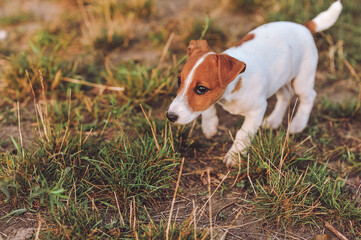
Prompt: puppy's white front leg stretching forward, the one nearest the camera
<box><xmin>223</xmin><ymin>104</ymin><xmax>267</xmax><ymax>166</ymax></box>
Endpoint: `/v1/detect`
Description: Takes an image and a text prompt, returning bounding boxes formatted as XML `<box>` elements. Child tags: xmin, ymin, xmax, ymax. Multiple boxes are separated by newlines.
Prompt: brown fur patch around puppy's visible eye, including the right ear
<box><xmin>186</xmin><ymin>54</ymin><xmax>246</xmax><ymax>112</ymax></box>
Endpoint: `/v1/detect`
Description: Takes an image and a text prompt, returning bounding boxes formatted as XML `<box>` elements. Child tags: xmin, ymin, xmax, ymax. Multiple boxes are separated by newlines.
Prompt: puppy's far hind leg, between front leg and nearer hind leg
<box><xmin>262</xmin><ymin>84</ymin><xmax>294</xmax><ymax>129</ymax></box>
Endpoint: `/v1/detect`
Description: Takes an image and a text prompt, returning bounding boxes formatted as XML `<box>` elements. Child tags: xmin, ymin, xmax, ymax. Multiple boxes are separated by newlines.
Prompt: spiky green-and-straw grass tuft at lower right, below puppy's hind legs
<box><xmin>251</xmin><ymin>166</ymin><xmax>319</xmax><ymax>226</ymax></box>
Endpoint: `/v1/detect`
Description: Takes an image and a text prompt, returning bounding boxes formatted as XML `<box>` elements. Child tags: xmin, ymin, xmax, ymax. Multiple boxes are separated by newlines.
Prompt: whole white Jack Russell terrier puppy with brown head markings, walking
<box><xmin>166</xmin><ymin>0</ymin><xmax>342</xmax><ymax>166</ymax></box>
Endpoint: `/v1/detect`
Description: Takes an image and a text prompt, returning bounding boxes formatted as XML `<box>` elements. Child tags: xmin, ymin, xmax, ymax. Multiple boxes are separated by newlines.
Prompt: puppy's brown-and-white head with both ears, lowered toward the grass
<box><xmin>167</xmin><ymin>40</ymin><xmax>246</xmax><ymax>124</ymax></box>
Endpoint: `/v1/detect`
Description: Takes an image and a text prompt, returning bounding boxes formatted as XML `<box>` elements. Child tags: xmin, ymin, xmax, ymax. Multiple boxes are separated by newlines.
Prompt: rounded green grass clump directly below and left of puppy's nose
<box><xmin>86</xmin><ymin>135</ymin><xmax>177</xmax><ymax>204</ymax></box>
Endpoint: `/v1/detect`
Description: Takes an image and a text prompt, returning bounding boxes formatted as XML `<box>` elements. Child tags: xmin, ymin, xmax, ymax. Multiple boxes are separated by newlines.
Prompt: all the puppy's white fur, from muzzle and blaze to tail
<box><xmin>168</xmin><ymin>1</ymin><xmax>342</xmax><ymax>165</ymax></box>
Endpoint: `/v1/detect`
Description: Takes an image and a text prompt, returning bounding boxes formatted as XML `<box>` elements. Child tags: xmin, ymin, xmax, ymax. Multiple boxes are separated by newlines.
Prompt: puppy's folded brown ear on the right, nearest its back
<box><xmin>217</xmin><ymin>54</ymin><xmax>246</xmax><ymax>87</ymax></box>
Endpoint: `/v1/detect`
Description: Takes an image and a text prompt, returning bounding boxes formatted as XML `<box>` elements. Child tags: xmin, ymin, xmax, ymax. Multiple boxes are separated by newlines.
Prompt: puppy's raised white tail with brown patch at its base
<box><xmin>305</xmin><ymin>0</ymin><xmax>342</xmax><ymax>33</ymax></box>
